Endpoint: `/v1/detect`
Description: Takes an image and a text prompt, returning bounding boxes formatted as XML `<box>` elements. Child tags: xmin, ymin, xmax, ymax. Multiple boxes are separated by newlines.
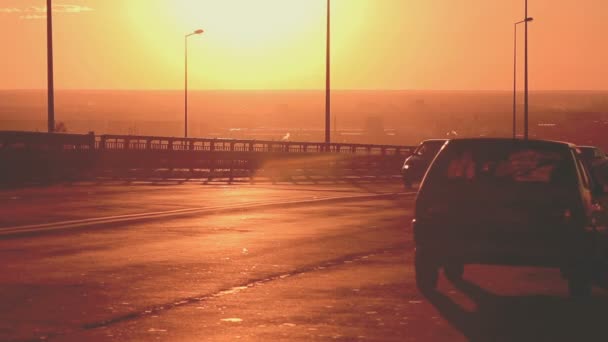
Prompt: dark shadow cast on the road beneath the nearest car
<box><xmin>425</xmin><ymin>280</ymin><xmax>608</xmax><ymax>341</ymax></box>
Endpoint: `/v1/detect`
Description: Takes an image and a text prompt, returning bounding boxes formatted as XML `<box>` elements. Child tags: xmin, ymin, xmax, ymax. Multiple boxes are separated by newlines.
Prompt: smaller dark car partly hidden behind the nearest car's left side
<box><xmin>401</xmin><ymin>139</ymin><xmax>447</xmax><ymax>188</ymax></box>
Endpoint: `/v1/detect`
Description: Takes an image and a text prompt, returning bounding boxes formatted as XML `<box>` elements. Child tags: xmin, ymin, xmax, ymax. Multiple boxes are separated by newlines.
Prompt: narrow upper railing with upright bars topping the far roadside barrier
<box><xmin>95</xmin><ymin>134</ymin><xmax>413</xmax><ymax>155</ymax></box>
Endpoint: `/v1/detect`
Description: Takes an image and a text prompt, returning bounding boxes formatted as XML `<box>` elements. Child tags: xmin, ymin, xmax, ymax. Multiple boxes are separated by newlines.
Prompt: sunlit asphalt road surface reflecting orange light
<box><xmin>0</xmin><ymin>182</ymin><xmax>608</xmax><ymax>341</ymax></box>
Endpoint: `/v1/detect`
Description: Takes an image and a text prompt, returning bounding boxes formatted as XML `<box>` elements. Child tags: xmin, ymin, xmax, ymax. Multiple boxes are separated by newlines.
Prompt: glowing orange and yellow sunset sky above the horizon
<box><xmin>0</xmin><ymin>0</ymin><xmax>608</xmax><ymax>90</ymax></box>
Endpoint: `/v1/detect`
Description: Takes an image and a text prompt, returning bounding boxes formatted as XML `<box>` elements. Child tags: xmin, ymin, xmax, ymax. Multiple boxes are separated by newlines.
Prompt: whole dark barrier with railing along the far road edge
<box><xmin>0</xmin><ymin>131</ymin><xmax>413</xmax><ymax>184</ymax></box>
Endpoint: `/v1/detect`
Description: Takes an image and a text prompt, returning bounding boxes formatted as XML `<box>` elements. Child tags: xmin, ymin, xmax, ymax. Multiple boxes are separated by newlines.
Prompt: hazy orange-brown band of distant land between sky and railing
<box><xmin>0</xmin><ymin>89</ymin><xmax>608</xmax><ymax>145</ymax></box>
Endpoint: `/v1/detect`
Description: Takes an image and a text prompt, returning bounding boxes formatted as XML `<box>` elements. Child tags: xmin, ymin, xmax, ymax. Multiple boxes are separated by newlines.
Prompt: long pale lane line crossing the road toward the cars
<box><xmin>0</xmin><ymin>192</ymin><xmax>415</xmax><ymax>236</ymax></box>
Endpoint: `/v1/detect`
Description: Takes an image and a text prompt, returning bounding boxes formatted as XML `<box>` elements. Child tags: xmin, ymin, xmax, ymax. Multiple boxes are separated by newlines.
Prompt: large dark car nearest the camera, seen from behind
<box><xmin>412</xmin><ymin>139</ymin><xmax>606</xmax><ymax>296</ymax></box>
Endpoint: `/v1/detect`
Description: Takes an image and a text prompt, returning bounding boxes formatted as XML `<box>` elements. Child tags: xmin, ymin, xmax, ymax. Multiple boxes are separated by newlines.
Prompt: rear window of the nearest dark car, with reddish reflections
<box><xmin>429</xmin><ymin>143</ymin><xmax>575</xmax><ymax>184</ymax></box>
